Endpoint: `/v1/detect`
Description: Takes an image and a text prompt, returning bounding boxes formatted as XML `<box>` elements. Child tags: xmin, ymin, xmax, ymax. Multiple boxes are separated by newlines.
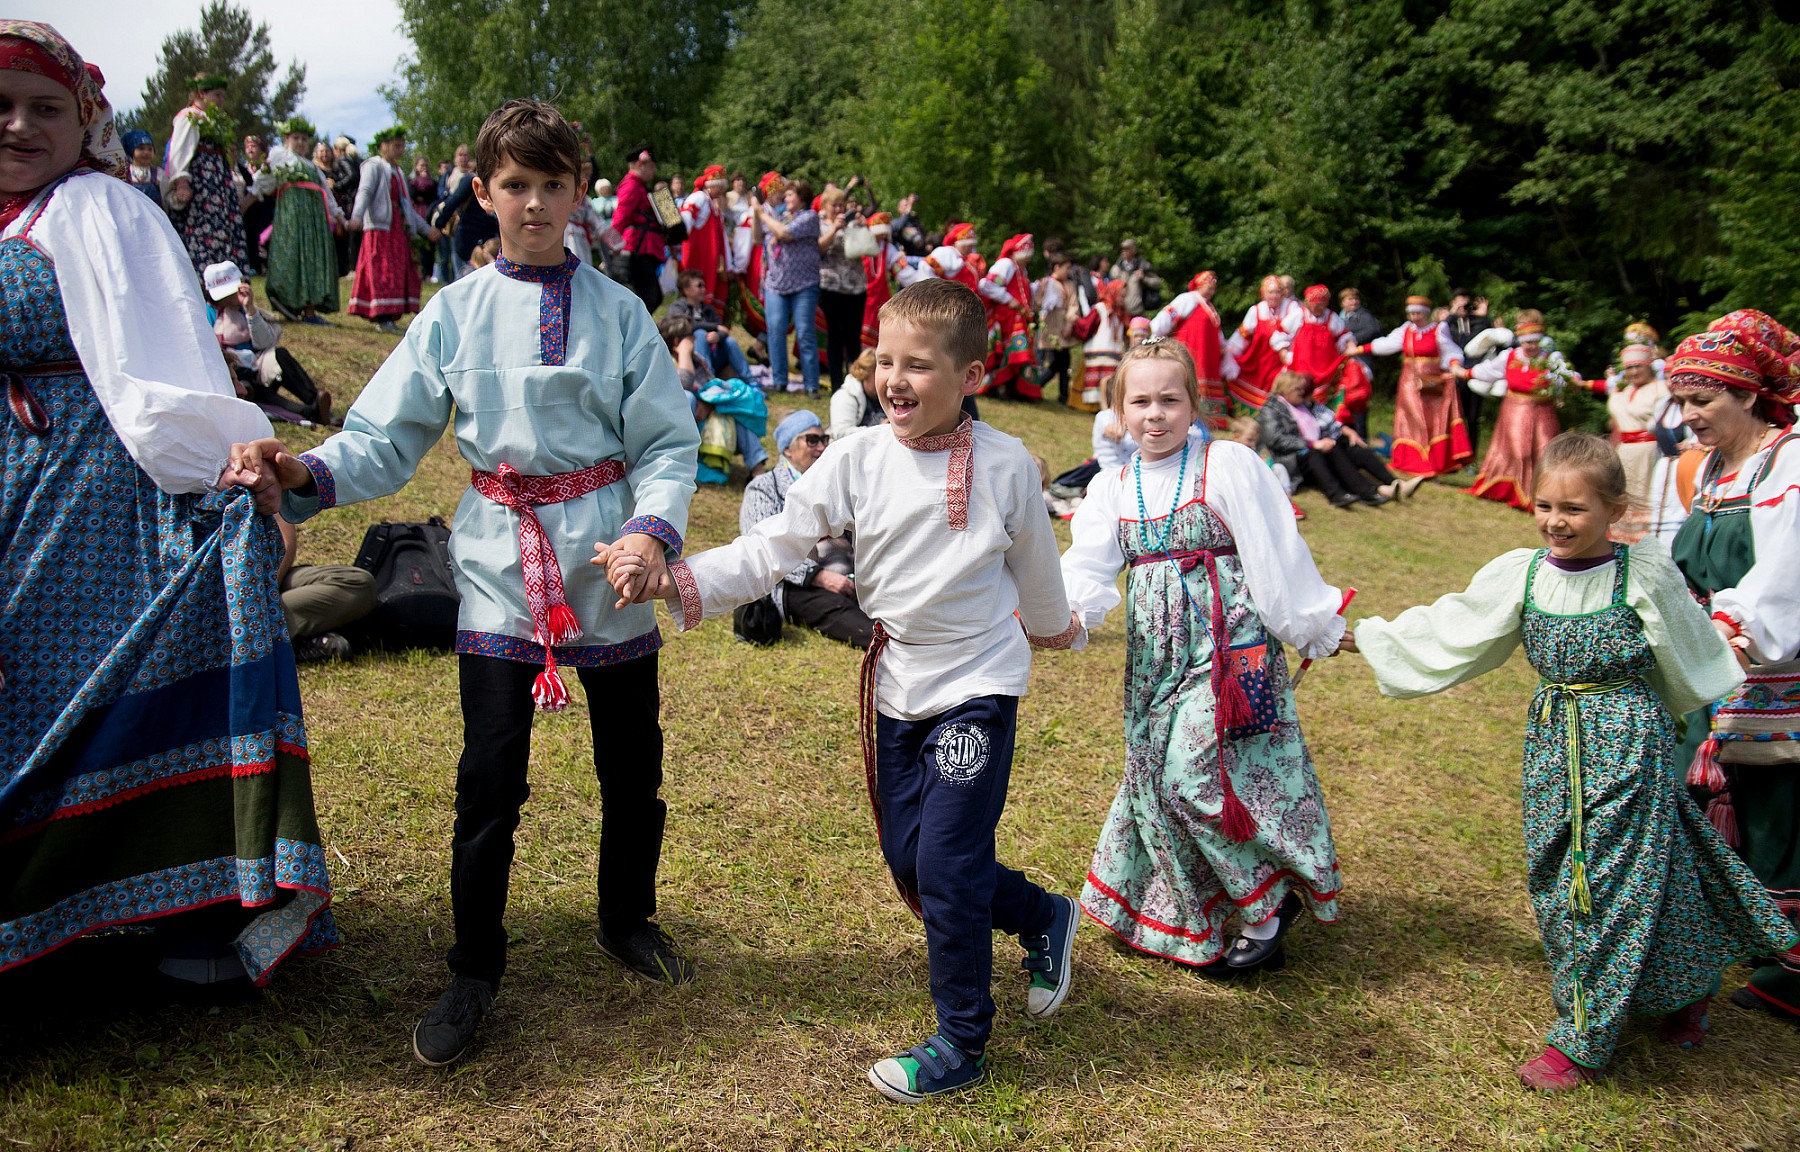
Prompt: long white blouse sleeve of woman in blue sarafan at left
<box><xmin>5</xmin><ymin>173</ymin><xmax>272</xmax><ymax>495</ymax></box>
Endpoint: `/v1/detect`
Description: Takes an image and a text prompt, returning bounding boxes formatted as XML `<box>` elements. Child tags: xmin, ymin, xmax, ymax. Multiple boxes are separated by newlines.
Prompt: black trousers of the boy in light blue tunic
<box><xmin>448</xmin><ymin>653</ymin><xmax>668</xmax><ymax>986</ymax></box>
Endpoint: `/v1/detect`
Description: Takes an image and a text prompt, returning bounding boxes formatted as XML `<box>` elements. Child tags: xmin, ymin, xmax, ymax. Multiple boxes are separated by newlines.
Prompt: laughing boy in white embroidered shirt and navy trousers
<box><xmin>594</xmin><ymin>279</ymin><xmax>1085</xmax><ymax>1102</ymax></box>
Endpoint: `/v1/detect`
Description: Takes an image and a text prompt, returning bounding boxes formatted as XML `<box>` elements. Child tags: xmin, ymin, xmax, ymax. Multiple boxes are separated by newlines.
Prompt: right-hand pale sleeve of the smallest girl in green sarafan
<box><xmin>1625</xmin><ymin>536</ymin><xmax>1744</xmax><ymax>716</ymax></box>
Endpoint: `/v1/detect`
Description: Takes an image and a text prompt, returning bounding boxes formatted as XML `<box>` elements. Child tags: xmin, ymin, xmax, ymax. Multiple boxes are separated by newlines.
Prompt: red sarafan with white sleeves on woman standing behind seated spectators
<box><xmin>1355</xmin><ymin>295</ymin><xmax>1474</xmax><ymax>475</ymax></box>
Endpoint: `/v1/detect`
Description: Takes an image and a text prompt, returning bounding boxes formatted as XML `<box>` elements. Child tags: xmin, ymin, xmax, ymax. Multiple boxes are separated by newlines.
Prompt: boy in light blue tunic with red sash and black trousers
<box><xmin>234</xmin><ymin>101</ymin><xmax>698</xmax><ymax>1066</ymax></box>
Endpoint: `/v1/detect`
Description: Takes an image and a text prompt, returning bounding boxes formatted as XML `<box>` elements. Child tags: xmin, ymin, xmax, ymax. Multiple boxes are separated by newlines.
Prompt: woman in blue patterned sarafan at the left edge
<box><xmin>0</xmin><ymin>20</ymin><xmax>335</xmax><ymax>985</ymax></box>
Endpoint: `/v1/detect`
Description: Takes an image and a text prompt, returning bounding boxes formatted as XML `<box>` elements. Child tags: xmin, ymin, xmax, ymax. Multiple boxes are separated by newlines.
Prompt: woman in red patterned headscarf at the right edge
<box><xmin>1665</xmin><ymin>310</ymin><xmax>1800</xmax><ymax>1022</ymax></box>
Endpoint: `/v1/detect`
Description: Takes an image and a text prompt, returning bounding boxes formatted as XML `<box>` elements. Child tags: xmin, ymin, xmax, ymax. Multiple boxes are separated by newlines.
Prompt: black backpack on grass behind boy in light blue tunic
<box><xmin>342</xmin><ymin>517</ymin><xmax>463</xmax><ymax>650</ymax></box>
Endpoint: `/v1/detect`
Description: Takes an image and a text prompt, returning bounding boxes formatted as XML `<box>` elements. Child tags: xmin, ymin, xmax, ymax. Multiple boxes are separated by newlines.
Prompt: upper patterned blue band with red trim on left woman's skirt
<box><xmin>0</xmin><ymin>713</ymin><xmax>308</xmax><ymax>842</ymax></box>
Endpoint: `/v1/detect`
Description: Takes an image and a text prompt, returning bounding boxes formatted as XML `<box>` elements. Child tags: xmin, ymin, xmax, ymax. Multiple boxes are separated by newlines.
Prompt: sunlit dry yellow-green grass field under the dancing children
<box><xmin>0</xmin><ymin>297</ymin><xmax>1800</xmax><ymax>1152</ymax></box>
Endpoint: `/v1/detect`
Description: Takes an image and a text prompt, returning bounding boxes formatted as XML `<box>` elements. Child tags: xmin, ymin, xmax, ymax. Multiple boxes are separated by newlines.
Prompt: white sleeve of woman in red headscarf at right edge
<box><xmin>1712</xmin><ymin>443</ymin><xmax>1800</xmax><ymax>664</ymax></box>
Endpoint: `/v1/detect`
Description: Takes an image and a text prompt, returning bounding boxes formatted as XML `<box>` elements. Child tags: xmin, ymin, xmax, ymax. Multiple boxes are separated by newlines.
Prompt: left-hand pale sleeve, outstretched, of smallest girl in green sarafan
<box><xmin>1355</xmin><ymin>547</ymin><xmax>1535</xmax><ymax>700</ymax></box>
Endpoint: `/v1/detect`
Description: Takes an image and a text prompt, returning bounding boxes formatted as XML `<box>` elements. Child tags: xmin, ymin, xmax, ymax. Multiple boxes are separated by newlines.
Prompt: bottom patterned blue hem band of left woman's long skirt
<box><xmin>0</xmin><ymin>837</ymin><xmax>338</xmax><ymax>986</ymax></box>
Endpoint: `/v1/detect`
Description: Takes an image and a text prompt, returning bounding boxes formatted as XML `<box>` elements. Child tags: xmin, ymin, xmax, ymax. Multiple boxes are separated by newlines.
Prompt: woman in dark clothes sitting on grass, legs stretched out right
<box><xmin>1256</xmin><ymin>369</ymin><xmax>1424</xmax><ymax>508</ymax></box>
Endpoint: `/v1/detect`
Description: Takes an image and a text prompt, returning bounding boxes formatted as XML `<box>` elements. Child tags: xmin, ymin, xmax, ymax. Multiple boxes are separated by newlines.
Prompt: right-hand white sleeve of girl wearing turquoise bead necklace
<box><xmin>1202</xmin><ymin>441</ymin><xmax>1345</xmax><ymax>659</ymax></box>
